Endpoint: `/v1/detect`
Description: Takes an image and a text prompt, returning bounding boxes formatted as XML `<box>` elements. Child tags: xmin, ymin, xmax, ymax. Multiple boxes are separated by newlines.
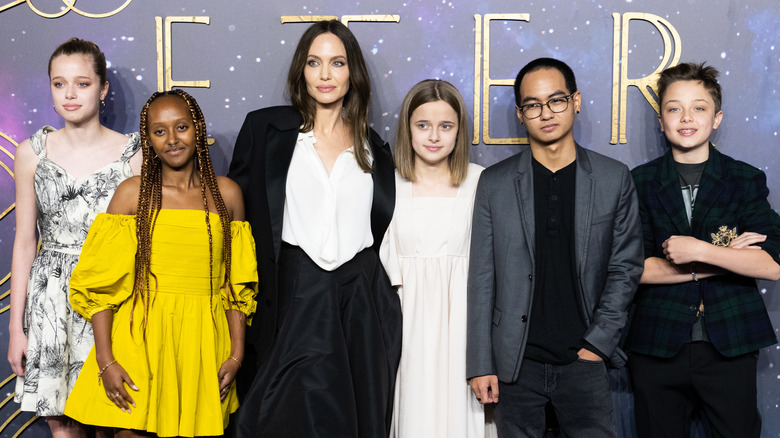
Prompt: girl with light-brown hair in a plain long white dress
<box><xmin>380</xmin><ymin>79</ymin><xmax>495</xmax><ymax>438</ymax></box>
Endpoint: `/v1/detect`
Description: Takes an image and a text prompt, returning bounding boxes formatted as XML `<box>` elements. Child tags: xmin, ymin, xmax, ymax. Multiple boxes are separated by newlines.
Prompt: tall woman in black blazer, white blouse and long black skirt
<box><xmin>228</xmin><ymin>21</ymin><xmax>401</xmax><ymax>437</ymax></box>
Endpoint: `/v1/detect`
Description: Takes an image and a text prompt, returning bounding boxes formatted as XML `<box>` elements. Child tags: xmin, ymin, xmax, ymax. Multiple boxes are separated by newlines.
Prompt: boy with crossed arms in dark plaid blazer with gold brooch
<box><xmin>626</xmin><ymin>63</ymin><xmax>780</xmax><ymax>438</ymax></box>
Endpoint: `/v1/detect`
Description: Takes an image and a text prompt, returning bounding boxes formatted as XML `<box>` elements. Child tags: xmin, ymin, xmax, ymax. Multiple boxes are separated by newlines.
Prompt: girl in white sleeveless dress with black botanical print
<box><xmin>8</xmin><ymin>38</ymin><xmax>141</xmax><ymax>438</ymax></box>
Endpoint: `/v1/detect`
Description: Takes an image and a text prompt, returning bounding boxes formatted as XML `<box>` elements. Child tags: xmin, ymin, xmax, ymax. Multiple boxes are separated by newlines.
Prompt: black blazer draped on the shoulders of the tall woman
<box><xmin>228</xmin><ymin>106</ymin><xmax>395</xmax><ymax>380</ymax></box>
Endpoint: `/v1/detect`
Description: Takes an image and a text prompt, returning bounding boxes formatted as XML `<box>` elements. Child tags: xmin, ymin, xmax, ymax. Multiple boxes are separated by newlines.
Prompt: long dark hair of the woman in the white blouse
<box><xmin>287</xmin><ymin>20</ymin><xmax>371</xmax><ymax>172</ymax></box>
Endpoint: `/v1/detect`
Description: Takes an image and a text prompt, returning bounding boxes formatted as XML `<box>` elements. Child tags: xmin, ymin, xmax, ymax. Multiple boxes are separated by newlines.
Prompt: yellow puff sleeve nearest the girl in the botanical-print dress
<box><xmin>70</xmin><ymin>213</ymin><xmax>138</xmax><ymax>321</ymax></box>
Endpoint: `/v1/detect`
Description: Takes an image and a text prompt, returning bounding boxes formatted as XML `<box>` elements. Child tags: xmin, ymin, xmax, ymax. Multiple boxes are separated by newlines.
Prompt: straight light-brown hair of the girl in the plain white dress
<box><xmin>395</xmin><ymin>79</ymin><xmax>469</xmax><ymax>185</ymax></box>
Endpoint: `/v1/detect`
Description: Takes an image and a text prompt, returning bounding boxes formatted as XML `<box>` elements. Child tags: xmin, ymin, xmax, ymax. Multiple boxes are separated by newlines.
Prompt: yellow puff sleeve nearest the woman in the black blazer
<box><xmin>221</xmin><ymin>221</ymin><xmax>258</xmax><ymax>325</ymax></box>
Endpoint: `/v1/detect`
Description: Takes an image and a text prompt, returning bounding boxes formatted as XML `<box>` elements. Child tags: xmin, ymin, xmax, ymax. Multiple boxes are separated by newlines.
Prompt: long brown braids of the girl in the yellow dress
<box><xmin>136</xmin><ymin>89</ymin><xmax>237</xmax><ymax>333</ymax></box>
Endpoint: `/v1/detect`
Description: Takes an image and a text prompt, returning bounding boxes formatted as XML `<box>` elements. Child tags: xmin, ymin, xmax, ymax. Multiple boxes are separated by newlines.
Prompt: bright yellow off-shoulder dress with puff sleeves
<box><xmin>65</xmin><ymin>209</ymin><xmax>257</xmax><ymax>437</ymax></box>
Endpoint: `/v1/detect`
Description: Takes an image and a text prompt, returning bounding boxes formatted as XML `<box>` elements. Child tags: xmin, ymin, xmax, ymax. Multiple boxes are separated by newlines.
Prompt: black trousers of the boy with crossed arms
<box><xmin>628</xmin><ymin>342</ymin><xmax>761</xmax><ymax>438</ymax></box>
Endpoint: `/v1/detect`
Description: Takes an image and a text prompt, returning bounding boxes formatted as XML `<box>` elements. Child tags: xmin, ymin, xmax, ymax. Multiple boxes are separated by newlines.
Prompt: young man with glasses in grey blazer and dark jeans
<box><xmin>467</xmin><ymin>58</ymin><xmax>643</xmax><ymax>438</ymax></box>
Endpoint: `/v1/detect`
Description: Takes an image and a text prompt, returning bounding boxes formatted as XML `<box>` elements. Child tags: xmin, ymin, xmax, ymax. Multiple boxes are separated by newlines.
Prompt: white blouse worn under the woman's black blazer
<box><xmin>282</xmin><ymin>131</ymin><xmax>374</xmax><ymax>271</ymax></box>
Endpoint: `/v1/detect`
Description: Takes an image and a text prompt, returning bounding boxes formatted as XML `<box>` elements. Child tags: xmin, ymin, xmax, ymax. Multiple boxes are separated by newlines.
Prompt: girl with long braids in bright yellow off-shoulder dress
<box><xmin>65</xmin><ymin>90</ymin><xmax>257</xmax><ymax>437</ymax></box>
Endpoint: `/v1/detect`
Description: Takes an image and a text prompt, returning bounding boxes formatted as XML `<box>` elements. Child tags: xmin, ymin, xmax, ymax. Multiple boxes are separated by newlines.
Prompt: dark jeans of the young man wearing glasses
<box><xmin>495</xmin><ymin>359</ymin><xmax>617</xmax><ymax>438</ymax></box>
